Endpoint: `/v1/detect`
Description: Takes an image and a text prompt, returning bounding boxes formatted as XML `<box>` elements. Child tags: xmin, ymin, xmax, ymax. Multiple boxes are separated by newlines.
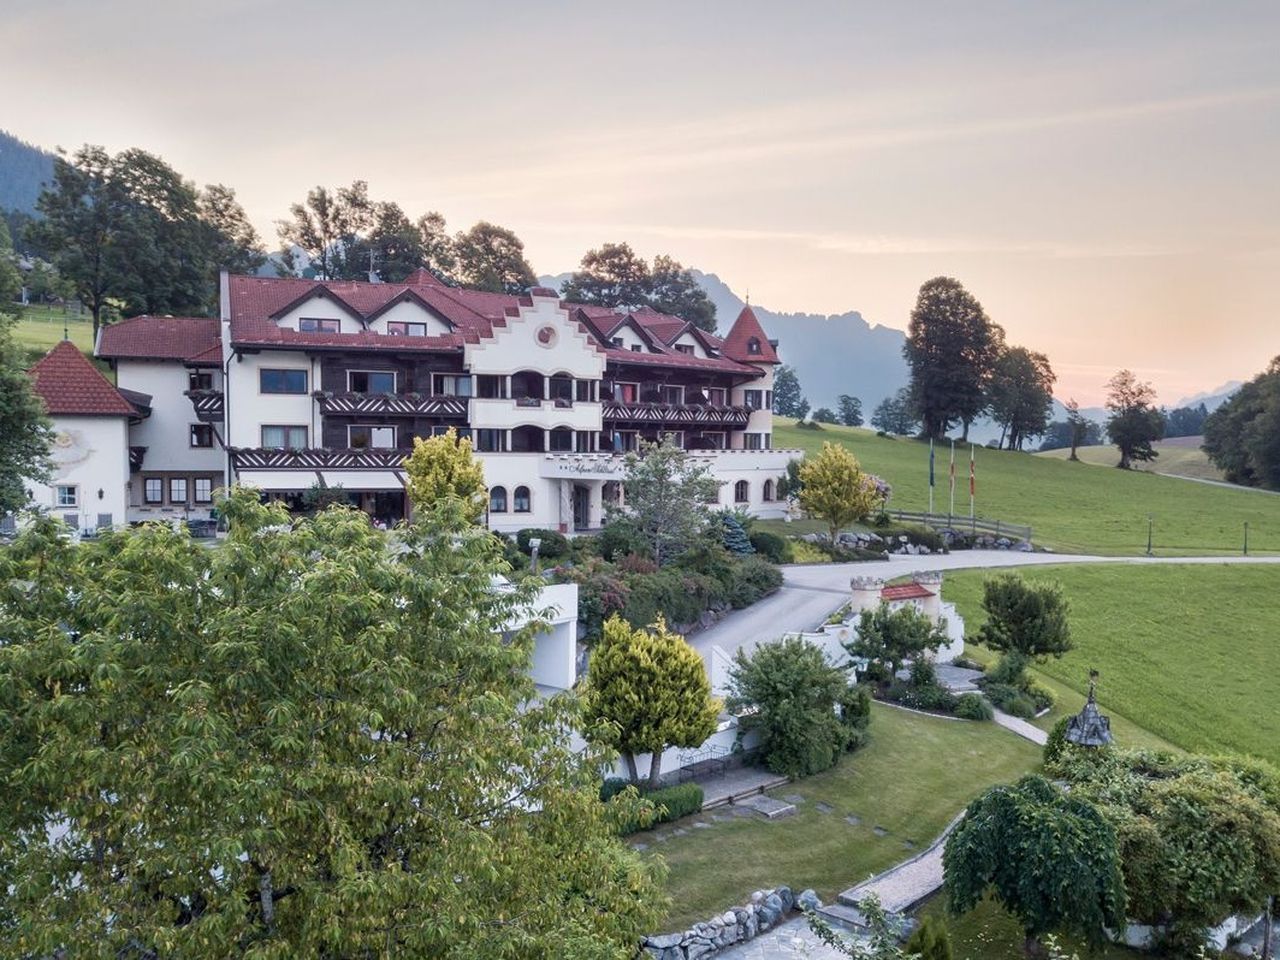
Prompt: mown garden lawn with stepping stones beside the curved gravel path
<box><xmin>632</xmin><ymin>704</ymin><xmax>1041</xmax><ymax>929</ymax></box>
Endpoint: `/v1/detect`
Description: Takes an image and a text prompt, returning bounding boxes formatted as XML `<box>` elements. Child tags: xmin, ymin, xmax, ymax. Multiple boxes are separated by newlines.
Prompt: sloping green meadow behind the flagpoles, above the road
<box><xmin>773</xmin><ymin>419</ymin><xmax>1280</xmax><ymax>556</ymax></box>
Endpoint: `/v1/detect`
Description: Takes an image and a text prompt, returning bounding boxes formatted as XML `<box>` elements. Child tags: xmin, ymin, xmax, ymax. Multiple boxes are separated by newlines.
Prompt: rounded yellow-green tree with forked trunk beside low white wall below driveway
<box><xmin>586</xmin><ymin>614</ymin><xmax>721</xmax><ymax>788</ymax></box>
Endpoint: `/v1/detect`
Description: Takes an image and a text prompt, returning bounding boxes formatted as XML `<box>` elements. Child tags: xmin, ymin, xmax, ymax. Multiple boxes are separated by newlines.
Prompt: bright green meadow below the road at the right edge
<box><xmin>943</xmin><ymin>563</ymin><xmax>1280</xmax><ymax>763</ymax></box>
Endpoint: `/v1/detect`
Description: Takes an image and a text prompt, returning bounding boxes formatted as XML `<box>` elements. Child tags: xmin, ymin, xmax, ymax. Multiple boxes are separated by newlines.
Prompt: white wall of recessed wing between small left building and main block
<box><xmin>115</xmin><ymin>360</ymin><xmax>223</xmax><ymax>474</ymax></box>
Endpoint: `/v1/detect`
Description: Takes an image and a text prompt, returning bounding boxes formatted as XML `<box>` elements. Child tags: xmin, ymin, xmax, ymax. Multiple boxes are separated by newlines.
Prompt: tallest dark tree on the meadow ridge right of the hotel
<box><xmin>902</xmin><ymin>276</ymin><xmax>1004</xmax><ymax>440</ymax></box>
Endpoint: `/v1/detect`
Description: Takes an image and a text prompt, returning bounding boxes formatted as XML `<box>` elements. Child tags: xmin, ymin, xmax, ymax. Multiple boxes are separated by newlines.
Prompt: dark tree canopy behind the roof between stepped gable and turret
<box><xmin>561</xmin><ymin>243</ymin><xmax>716</xmax><ymax>333</ymax></box>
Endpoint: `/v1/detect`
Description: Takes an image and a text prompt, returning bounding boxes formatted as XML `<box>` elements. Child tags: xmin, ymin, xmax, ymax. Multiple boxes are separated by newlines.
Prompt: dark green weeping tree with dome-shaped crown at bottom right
<box><xmin>942</xmin><ymin>776</ymin><xmax>1125</xmax><ymax>956</ymax></box>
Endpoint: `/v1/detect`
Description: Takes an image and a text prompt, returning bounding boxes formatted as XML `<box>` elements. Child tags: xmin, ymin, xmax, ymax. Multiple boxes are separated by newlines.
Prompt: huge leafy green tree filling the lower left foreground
<box><xmin>0</xmin><ymin>490</ymin><xmax>660</xmax><ymax>960</ymax></box>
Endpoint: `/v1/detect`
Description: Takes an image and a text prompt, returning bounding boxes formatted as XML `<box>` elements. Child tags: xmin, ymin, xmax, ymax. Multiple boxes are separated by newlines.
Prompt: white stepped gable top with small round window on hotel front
<box><xmin>465</xmin><ymin>297</ymin><xmax>604</xmax><ymax>380</ymax></box>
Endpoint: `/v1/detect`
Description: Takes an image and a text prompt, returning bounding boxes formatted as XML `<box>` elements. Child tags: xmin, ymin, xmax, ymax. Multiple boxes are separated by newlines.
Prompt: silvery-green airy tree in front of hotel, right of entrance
<box><xmin>621</xmin><ymin>436</ymin><xmax>719</xmax><ymax>567</ymax></box>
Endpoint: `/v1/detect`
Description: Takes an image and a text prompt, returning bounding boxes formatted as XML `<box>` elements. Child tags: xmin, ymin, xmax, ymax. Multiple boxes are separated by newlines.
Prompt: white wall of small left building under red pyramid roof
<box><xmin>27</xmin><ymin>416</ymin><xmax>129</xmax><ymax>530</ymax></box>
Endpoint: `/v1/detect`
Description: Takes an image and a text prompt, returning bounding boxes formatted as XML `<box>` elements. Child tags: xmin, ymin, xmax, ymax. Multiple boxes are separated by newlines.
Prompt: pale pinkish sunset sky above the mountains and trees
<box><xmin>0</xmin><ymin>0</ymin><xmax>1280</xmax><ymax>406</ymax></box>
